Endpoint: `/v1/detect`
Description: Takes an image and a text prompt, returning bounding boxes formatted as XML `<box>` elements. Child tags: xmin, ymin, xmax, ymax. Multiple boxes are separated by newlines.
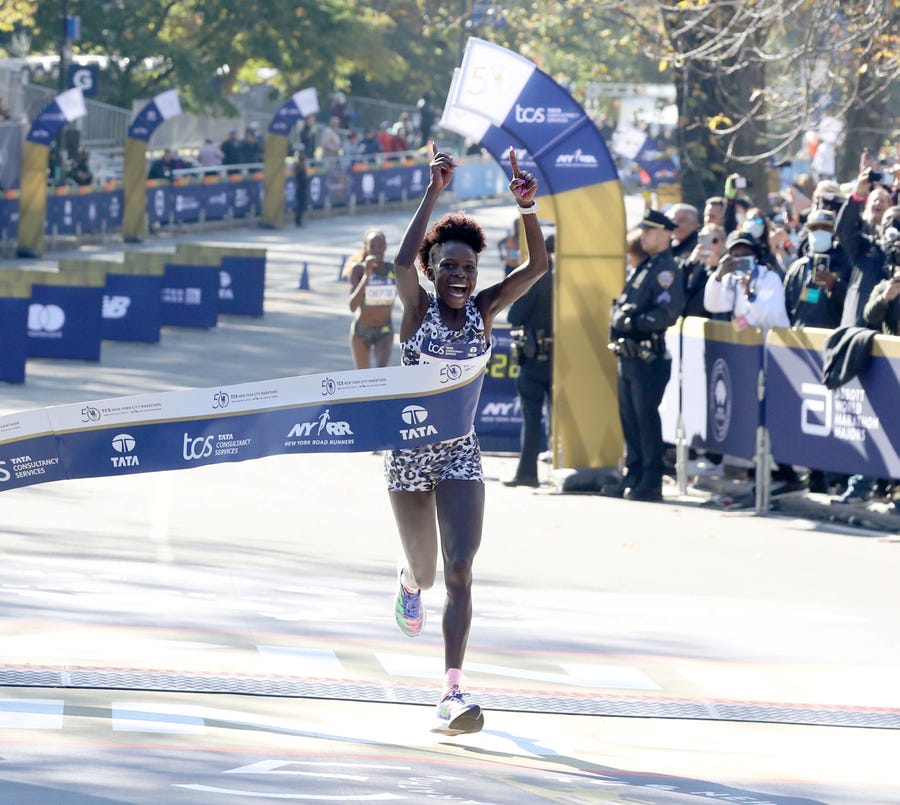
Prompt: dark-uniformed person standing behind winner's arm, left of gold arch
<box><xmin>503</xmin><ymin>235</ymin><xmax>556</xmax><ymax>486</ymax></box>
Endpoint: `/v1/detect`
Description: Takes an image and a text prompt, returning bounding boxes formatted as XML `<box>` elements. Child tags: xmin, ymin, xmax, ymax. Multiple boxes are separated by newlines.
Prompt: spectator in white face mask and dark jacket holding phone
<box><xmin>784</xmin><ymin>210</ymin><xmax>850</xmax><ymax>330</ymax></box>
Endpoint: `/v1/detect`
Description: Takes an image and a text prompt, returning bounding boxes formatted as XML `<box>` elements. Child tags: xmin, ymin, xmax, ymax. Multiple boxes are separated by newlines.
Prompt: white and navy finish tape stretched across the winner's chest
<box><xmin>0</xmin><ymin>353</ymin><xmax>490</xmax><ymax>490</ymax></box>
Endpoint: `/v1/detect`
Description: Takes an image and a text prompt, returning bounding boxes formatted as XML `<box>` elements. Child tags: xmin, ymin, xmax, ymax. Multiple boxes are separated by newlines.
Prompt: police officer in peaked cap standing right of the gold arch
<box><xmin>603</xmin><ymin>210</ymin><xmax>684</xmax><ymax>501</ymax></box>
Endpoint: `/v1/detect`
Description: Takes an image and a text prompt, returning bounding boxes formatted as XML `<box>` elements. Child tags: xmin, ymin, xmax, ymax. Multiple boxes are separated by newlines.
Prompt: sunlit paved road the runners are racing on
<box><xmin>0</xmin><ymin>206</ymin><xmax>900</xmax><ymax>805</ymax></box>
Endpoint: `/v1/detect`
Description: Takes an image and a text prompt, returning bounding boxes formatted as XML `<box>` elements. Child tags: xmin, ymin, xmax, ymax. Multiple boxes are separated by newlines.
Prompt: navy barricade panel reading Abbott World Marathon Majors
<box><xmin>766</xmin><ymin>328</ymin><xmax>900</xmax><ymax>478</ymax></box>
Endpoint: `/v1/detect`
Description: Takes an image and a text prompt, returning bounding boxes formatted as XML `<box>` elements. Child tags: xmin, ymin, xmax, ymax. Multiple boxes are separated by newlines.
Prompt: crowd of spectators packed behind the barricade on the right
<box><xmin>629</xmin><ymin>151</ymin><xmax>900</xmax><ymax>513</ymax></box>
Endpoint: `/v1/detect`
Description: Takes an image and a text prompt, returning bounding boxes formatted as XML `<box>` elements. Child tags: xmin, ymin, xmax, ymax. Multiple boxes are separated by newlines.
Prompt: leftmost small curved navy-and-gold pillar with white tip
<box><xmin>17</xmin><ymin>89</ymin><xmax>87</xmax><ymax>257</ymax></box>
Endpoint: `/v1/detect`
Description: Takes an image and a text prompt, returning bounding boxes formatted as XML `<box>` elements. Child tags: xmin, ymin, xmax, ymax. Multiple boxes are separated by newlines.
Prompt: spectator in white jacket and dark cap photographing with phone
<box><xmin>703</xmin><ymin>230</ymin><xmax>791</xmax><ymax>330</ymax></box>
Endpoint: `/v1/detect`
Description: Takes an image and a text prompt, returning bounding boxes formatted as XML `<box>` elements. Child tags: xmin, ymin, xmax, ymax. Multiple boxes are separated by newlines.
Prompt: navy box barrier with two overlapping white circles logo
<box><xmin>26</xmin><ymin>284</ymin><xmax>103</xmax><ymax>361</ymax></box>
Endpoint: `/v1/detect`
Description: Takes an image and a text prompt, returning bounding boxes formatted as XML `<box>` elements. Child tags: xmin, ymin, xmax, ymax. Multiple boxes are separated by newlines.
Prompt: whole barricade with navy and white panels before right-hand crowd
<box><xmin>660</xmin><ymin>317</ymin><xmax>900</xmax><ymax>513</ymax></box>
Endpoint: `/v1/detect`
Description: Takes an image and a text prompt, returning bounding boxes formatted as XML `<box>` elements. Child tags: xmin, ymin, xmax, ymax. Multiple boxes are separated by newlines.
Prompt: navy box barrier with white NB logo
<box><xmin>100</xmin><ymin>274</ymin><xmax>163</xmax><ymax>344</ymax></box>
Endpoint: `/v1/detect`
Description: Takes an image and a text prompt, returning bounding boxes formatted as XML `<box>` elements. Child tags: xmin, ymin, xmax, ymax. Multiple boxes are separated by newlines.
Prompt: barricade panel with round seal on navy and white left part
<box><xmin>681</xmin><ymin>316</ymin><xmax>763</xmax><ymax>459</ymax></box>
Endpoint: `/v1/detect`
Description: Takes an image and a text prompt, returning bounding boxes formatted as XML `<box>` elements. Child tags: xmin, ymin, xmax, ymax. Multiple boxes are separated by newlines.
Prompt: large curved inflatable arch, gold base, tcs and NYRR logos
<box><xmin>441</xmin><ymin>38</ymin><xmax>625</xmax><ymax>467</ymax></box>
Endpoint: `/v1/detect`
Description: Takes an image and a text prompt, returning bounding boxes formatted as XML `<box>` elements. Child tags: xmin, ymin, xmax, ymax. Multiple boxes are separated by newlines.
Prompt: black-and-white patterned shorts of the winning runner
<box><xmin>384</xmin><ymin>431</ymin><xmax>484</xmax><ymax>492</ymax></box>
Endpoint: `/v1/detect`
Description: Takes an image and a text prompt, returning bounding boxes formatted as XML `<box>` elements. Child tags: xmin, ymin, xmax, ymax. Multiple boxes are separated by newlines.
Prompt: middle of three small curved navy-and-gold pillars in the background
<box><xmin>122</xmin><ymin>89</ymin><xmax>181</xmax><ymax>242</ymax></box>
